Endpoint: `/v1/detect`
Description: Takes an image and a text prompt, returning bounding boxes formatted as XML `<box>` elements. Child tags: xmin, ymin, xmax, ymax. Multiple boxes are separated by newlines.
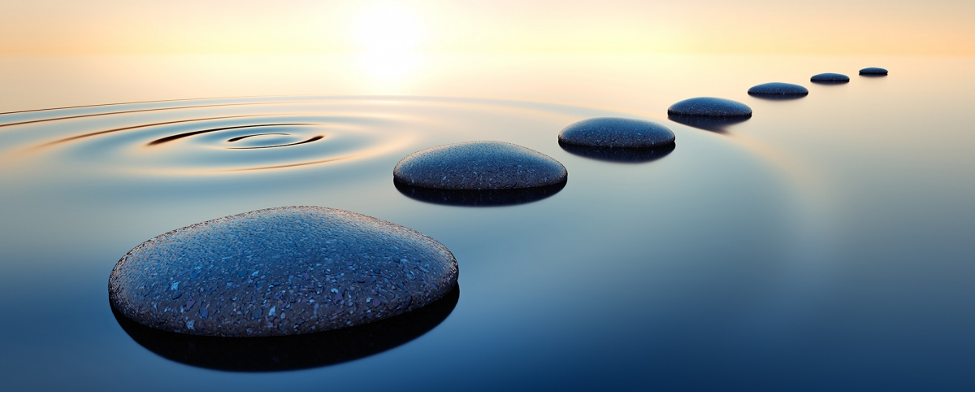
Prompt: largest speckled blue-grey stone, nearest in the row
<box><xmin>109</xmin><ymin>207</ymin><xmax>458</xmax><ymax>337</ymax></box>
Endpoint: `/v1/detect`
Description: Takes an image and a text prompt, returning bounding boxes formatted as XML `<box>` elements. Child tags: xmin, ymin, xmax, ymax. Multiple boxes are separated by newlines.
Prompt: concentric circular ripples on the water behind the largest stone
<box><xmin>0</xmin><ymin>97</ymin><xmax>413</xmax><ymax>174</ymax></box>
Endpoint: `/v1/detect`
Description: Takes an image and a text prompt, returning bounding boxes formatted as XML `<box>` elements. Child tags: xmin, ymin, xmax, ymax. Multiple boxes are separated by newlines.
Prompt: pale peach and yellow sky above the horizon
<box><xmin>0</xmin><ymin>0</ymin><xmax>974</xmax><ymax>56</ymax></box>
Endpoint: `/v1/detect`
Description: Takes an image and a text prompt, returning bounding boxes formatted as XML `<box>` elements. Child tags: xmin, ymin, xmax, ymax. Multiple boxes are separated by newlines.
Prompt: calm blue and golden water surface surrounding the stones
<box><xmin>0</xmin><ymin>55</ymin><xmax>974</xmax><ymax>390</ymax></box>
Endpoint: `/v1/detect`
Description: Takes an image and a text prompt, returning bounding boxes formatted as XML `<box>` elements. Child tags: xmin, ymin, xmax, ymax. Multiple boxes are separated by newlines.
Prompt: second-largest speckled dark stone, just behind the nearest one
<box><xmin>394</xmin><ymin>142</ymin><xmax>567</xmax><ymax>190</ymax></box>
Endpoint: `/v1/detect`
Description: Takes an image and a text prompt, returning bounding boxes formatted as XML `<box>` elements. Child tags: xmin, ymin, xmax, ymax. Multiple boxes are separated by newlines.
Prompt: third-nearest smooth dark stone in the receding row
<box><xmin>558</xmin><ymin>117</ymin><xmax>675</xmax><ymax>148</ymax></box>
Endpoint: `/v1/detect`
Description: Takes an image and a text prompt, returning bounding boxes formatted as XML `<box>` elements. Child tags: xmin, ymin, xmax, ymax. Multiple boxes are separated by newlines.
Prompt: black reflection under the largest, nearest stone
<box><xmin>112</xmin><ymin>285</ymin><xmax>460</xmax><ymax>371</ymax></box>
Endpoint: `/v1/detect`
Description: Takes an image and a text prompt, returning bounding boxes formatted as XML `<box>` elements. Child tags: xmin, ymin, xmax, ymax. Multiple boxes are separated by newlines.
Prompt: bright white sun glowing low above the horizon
<box><xmin>354</xmin><ymin>2</ymin><xmax>421</xmax><ymax>55</ymax></box>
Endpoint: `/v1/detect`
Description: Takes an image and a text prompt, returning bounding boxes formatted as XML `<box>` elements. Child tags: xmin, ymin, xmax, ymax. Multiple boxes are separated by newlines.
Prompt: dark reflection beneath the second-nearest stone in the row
<box><xmin>394</xmin><ymin>180</ymin><xmax>567</xmax><ymax>207</ymax></box>
